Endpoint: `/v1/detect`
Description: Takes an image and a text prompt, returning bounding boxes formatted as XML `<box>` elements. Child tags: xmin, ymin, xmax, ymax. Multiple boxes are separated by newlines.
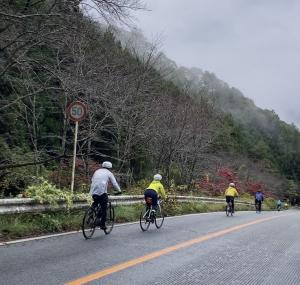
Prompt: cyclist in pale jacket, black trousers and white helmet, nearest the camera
<box><xmin>90</xmin><ymin>161</ymin><xmax>121</xmax><ymax>230</ymax></box>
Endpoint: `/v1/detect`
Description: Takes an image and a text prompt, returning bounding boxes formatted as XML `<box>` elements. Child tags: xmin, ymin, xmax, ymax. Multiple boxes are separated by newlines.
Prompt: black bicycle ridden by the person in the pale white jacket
<box><xmin>82</xmin><ymin>193</ymin><xmax>115</xmax><ymax>239</ymax></box>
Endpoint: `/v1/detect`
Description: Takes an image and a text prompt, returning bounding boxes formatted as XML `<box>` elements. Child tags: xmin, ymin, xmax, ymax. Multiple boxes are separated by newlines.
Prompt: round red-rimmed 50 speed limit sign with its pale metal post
<box><xmin>67</xmin><ymin>101</ymin><xmax>87</xmax><ymax>193</ymax></box>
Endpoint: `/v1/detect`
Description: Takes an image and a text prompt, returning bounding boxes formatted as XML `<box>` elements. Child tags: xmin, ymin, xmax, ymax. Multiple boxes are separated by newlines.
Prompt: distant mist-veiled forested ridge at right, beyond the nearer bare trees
<box><xmin>164</xmin><ymin>63</ymin><xmax>300</xmax><ymax>180</ymax></box>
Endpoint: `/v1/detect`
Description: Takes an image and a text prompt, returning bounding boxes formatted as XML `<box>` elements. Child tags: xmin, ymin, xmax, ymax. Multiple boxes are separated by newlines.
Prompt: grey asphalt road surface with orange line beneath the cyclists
<box><xmin>0</xmin><ymin>211</ymin><xmax>300</xmax><ymax>285</ymax></box>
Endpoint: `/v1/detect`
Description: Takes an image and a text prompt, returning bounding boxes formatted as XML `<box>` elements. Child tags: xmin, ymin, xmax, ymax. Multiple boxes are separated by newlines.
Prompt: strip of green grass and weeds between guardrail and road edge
<box><xmin>0</xmin><ymin>196</ymin><xmax>275</xmax><ymax>241</ymax></box>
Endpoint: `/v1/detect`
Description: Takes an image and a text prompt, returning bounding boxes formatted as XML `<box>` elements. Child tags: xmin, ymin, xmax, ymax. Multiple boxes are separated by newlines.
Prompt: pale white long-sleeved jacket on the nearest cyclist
<box><xmin>90</xmin><ymin>168</ymin><xmax>121</xmax><ymax>196</ymax></box>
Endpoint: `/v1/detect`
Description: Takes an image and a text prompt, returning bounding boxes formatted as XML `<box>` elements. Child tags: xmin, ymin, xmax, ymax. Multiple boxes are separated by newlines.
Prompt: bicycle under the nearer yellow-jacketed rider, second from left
<box><xmin>140</xmin><ymin>197</ymin><xmax>165</xmax><ymax>232</ymax></box>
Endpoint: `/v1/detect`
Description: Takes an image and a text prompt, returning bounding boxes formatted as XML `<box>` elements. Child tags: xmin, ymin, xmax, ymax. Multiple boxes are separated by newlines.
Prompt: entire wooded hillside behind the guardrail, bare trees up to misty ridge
<box><xmin>0</xmin><ymin>0</ymin><xmax>300</xmax><ymax>201</ymax></box>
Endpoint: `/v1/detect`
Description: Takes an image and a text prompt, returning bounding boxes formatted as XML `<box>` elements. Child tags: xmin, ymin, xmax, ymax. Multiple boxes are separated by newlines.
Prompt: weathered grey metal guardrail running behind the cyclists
<box><xmin>0</xmin><ymin>195</ymin><xmax>254</xmax><ymax>215</ymax></box>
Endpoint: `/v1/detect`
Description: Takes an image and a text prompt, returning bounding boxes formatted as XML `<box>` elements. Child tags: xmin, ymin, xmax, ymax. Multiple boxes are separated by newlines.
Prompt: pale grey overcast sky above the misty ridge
<box><xmin>134</xmin><ymin>0</ymin><xmax>300</xmax><ymax>128</ymax></box>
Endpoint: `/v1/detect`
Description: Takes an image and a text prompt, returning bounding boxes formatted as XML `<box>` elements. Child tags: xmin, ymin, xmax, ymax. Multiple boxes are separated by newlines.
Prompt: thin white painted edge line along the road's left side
<box><xmin>0</xmin><ymin>211</ymin><xmax>258</xmax><ymax>246</ymax></box>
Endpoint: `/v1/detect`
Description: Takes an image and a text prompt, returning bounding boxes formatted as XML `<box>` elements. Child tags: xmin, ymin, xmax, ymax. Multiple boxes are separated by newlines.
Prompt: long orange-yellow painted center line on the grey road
<box><xmin>65</xmin><ymin>216</ymin><xmax>282</xmax><ymax>285</ymax></box>
